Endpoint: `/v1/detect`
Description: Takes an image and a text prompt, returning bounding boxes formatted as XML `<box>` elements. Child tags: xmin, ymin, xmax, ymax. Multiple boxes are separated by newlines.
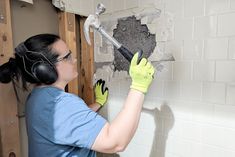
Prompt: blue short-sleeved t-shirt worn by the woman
<box><xmin>26</xmin><ymin>87</ymin><xmax>106</xmax><ymax>157</ymax></box>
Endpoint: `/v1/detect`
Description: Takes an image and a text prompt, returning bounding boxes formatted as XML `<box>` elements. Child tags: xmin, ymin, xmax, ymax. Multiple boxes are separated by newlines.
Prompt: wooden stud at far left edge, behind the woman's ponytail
<box><xmin>0</xmin><ymin>0</ymin><xmax>20</xmax><ymax>157</ymax></box>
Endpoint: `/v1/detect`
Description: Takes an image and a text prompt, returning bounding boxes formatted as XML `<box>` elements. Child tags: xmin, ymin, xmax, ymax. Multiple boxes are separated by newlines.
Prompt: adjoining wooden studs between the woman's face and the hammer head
<box><xmin>58</xmin><ymin>11</ymin><xmax>94</xmax><ymax>105</ymax></box>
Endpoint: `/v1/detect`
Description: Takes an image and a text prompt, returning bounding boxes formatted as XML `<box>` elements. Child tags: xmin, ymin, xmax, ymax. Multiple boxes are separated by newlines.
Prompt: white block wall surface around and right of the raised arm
<box><xmin>93</xmin><ymin>0</ymin><xmax>235</xmax><ymax>157</ymax></box>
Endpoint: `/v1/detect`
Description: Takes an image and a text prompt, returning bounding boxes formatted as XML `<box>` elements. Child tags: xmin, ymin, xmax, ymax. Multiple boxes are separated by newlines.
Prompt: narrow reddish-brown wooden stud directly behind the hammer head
<box><xmin>79</xmin><ymin>18</ymin><xmax>94</xmax><ymax>104</ymax></box>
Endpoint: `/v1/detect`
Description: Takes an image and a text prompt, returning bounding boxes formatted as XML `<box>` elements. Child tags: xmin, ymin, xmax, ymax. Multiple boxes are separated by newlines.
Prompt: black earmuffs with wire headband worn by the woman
<box><xmin>15</xmin><ymin>42</ymin><xmax>58</xmax><ymax>84</ymax></box>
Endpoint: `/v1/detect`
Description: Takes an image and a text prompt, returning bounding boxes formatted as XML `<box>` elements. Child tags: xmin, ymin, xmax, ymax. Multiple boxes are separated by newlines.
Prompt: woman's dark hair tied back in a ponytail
<box><xmin>0</xmin><ymin>34</ymin><xmax>60</xmax><ymax>90</ymax></box>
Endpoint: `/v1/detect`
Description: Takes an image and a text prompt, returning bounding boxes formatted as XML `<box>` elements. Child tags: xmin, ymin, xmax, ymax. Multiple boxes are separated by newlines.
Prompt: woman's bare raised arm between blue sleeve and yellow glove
<box><xmin>92</xmin><ymin>89</ymin><xmax>144</xmax><ymax>153</ymax></box>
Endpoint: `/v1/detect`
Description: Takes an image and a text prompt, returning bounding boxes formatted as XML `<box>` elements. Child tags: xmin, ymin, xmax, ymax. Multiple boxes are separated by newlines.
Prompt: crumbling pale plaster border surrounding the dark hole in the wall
<box><xmin>94</xmin><ymin>7</ymin><xmax>174</xmax><ymax>82</ymax></box>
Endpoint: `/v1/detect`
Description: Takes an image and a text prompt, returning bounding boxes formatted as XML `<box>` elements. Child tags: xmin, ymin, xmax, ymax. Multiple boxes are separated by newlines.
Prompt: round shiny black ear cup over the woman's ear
<box><xmin>31</xmin><ymin>61</ymin><xmax>58</xmax><ymax>84</ymax></box>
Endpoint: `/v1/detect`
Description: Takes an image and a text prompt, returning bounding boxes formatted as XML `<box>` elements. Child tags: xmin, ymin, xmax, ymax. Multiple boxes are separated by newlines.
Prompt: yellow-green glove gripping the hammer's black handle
<box><xmin>129</xmin><ymin>53</ymin><xmax>155</xmax><ymax>93</ymax></box>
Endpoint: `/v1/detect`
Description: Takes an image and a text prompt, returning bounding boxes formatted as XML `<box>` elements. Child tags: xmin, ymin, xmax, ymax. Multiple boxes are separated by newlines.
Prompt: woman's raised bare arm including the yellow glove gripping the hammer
<box><xmin>92</xmin><ymin>54</ymin><xmax>154</xmax><ymax>153</ymax></box>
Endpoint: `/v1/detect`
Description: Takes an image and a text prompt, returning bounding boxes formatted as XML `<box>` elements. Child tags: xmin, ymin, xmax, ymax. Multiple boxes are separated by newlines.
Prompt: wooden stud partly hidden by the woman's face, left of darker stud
<box><xmin>58</xmin><ymin>12</ymin><xmax>78</xmax><ymax>95</ymax></box>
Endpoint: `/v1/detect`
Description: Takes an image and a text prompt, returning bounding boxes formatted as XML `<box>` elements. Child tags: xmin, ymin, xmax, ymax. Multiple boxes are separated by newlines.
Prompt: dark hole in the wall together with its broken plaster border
<box><xmin>94</xmin><ymin>8</ymin><xmax>173</xmax><ymax>82</ymax></box>
